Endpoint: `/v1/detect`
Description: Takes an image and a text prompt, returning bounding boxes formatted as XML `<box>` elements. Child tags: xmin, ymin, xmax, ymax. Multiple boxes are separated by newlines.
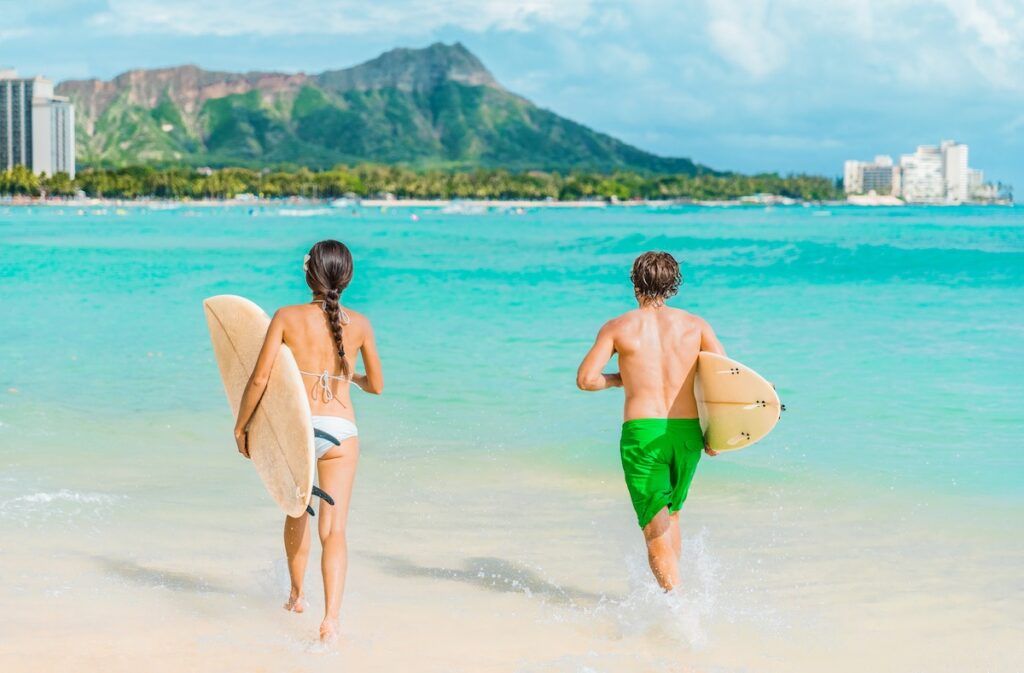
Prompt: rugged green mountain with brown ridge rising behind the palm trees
<box><xmin>57</xmin><ymin>43</ymin><xmax>710</xmax><ymax>174</ymax></box>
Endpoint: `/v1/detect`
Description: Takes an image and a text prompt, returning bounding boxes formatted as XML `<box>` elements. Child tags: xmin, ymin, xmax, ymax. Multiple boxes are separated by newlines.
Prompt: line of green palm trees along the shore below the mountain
<box><xmin>0</xmin><ymin>164</ymin><xmax>842</xmax><ymax>201</ymax></box>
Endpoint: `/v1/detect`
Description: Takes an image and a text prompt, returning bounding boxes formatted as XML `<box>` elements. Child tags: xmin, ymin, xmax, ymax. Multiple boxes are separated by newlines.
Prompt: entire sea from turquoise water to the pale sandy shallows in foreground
<box><xmin>0</xmin><ymin>201</ymin><xmax>1024</xmax><ymax>672</ymax></box>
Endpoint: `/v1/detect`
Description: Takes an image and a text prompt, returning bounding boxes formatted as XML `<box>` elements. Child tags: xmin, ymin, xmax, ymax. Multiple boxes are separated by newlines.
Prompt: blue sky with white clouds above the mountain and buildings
<box><xmin>0</xmin><ymin>0</ymin><xmax>1024</xmax><ymax>188</ymax></box>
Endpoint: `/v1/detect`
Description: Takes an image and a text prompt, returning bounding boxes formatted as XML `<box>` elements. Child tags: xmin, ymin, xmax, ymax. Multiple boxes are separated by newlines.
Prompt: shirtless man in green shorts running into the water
<box><xmin>577</xmin><ymin>252</ymin><xmax>725</xmax><ymax>591</ymax></box>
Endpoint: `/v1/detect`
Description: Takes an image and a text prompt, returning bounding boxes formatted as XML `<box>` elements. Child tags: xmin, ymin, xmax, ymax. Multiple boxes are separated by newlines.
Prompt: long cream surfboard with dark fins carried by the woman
<box><xmin>203</xmin><ymin>294</ymin><xmax>316</xmax><ymax>516</ymax></box>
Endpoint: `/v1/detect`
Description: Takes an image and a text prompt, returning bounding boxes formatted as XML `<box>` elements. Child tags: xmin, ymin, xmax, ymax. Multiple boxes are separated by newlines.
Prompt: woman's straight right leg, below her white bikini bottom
<box><xmin>316</xmin><ymin>437</ymin><xmax>359</xmax><ymax>640</ymax></box>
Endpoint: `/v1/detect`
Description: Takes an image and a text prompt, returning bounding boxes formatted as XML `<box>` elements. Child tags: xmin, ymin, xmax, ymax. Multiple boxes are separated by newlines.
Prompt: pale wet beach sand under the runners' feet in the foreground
<box><xmin>0</xmin><ymin>409</ymin><xmax>1024</xmax><ymax>672</ymax></box>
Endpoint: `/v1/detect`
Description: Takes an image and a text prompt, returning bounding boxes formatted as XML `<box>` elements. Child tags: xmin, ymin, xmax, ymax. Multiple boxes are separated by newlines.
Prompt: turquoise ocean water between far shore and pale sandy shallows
<box><xmin>0</xmin><ymin>201</ymin><xmax>1024</xmax><ymax>503</ymax></box>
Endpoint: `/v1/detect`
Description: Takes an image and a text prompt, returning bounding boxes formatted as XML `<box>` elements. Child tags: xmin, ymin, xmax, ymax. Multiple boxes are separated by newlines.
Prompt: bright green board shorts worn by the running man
<box><xmin>618</xmin><ymin>418</ymin><xmax>703</xmax><ymax>528</ymax></box>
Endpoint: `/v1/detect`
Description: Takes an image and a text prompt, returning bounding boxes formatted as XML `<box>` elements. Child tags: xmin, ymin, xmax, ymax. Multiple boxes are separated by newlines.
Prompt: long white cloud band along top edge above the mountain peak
<box><xmin>90</xmin><ymin>0</ymin><xmax>591</xmax><ymax>37</ymax></box>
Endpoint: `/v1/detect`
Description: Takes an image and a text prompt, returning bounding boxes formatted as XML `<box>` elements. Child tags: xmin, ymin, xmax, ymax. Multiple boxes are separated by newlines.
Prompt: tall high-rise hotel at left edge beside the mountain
<box><xmin>0</xmin><ymin>70</ymin><xmax>75</xmax><ymax>177</ymax></box>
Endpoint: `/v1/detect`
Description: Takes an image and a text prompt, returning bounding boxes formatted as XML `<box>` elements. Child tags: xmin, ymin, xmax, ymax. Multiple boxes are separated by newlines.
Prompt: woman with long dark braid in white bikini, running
<box><xmin>234</xmin><ymin>241</ymin><xmax>384</xmax><ymax>641</ymax></box>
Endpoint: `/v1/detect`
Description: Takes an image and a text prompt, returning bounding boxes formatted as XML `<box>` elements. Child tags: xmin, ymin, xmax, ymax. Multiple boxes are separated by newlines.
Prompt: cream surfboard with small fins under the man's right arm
<box><xmin>693</xmin><ymin>351</ymin><xmax>782</xmax><ymax>452</ymax></box>
